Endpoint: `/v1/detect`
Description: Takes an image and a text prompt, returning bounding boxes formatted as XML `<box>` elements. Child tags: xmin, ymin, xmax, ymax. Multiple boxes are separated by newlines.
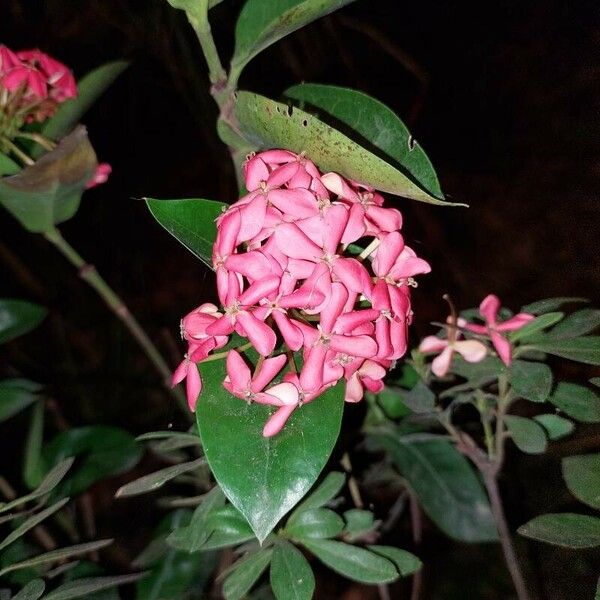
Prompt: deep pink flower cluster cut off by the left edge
<box><xmin>0</xmin><ymin>45</ymin><xmax>77</xmax><ymax>122</ymax></box>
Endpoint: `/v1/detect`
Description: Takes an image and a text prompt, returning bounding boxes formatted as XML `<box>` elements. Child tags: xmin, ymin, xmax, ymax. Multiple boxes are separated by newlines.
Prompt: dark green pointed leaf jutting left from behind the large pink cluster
<box><xmin>146</xmin><ymin>198</ymin><xmax>227</xmax><ymax>269</ymax></box>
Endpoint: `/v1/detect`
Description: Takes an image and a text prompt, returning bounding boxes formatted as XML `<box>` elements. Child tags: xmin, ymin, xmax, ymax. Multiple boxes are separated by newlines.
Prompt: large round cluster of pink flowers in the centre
<box><xmin>174</xmin><ymin>150</ymin><xmax>430</xmax><ymax>436</ymax></box>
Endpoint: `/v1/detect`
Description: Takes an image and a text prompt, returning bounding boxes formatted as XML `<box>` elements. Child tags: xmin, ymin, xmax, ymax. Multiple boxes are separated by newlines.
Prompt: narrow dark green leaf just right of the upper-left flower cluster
<box><xmin>42</xmin><ymin>60</ymin><xmax>129</xmax><ymax>145</ymax></box>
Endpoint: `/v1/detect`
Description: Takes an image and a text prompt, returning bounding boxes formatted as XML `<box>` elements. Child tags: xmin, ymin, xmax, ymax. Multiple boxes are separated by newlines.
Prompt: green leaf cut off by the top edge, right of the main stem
<box><xmin>231</xmin><ymin>0</ymin><xmax>353</xmax><ymax>73</ymax></box>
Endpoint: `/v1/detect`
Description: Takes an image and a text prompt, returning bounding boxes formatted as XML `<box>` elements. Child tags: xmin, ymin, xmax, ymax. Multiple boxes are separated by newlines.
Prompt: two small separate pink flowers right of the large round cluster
<box><xmin>419</xmin><ymin>294</ymin><xmax>535</xmax><ymax>377</ymax></box>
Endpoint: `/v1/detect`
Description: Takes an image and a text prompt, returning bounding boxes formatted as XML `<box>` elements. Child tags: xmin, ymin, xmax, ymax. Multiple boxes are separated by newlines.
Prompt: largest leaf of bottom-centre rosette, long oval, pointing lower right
<box><xmin>302</xmin><ymin>539</ymin><xmax>398</xmax><ymax>583</ymax></box>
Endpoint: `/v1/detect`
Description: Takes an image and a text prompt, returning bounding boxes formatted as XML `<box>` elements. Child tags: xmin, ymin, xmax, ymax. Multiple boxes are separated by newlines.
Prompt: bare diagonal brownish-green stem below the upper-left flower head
<box><xmin>44</xmin><ymin>228</ymin><xmax>189</xmax><ymax>418</ymax></box>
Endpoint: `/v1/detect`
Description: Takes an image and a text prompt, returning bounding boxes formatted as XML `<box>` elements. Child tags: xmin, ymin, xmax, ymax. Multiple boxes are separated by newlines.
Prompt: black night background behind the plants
<box><xmin>0</xmin><ymin>0</ymin><xmax>600</xmax><ymax>599</ymax></box>
